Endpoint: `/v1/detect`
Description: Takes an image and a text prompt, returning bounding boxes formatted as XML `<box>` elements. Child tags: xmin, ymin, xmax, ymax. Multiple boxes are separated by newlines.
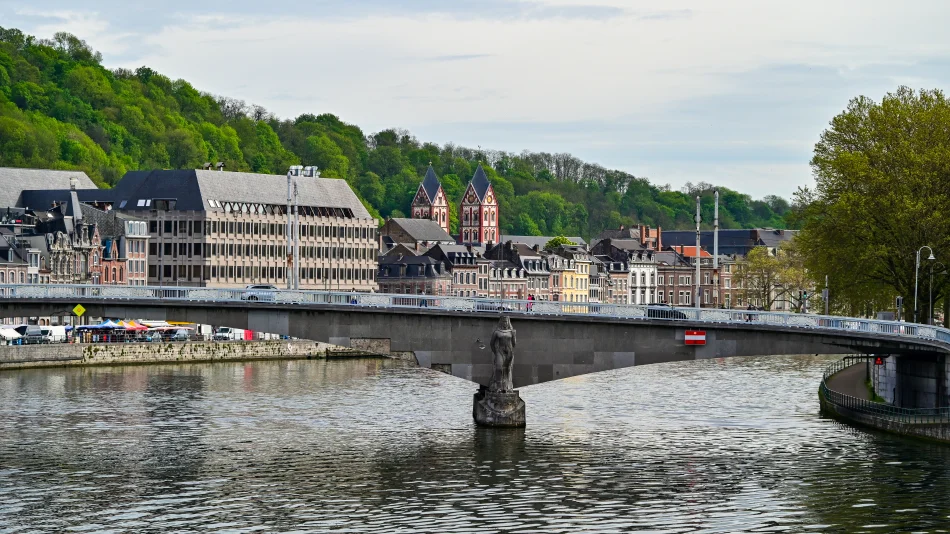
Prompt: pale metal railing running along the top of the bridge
<box><xmin>0</xmin><ymin>284</ymin><xmax>950</xmax><ymax>343</ymax></box>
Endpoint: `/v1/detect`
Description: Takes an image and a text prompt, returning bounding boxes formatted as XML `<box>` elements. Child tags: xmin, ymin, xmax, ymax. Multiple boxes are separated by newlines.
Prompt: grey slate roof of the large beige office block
<box><xmin>112</xmin><ymin>169</ymin><xmax>370</xmax><ymax>219</ymax></box>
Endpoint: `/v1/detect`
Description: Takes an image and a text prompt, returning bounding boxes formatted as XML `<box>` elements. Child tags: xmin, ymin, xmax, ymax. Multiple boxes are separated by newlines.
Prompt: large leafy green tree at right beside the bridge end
<box><xmin>800</xmin><ymin>87</ymin><xmax>950</xmax><ymax>318</ymax></box>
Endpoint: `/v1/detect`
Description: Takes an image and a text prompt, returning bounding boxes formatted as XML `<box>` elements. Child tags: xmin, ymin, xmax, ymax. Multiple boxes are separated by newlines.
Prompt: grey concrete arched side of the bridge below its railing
<box><xmin>0</xmin><ymin>299</ymin><xmax>947</xmax><ymax>387</ymax></box>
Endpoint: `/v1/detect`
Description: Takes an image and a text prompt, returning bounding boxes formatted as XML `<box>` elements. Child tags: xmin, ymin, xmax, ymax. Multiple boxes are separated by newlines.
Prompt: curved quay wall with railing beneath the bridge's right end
<box><xmin>818</xmin><ymin>362</ymin><xmax>950</xmax><ymax>443</ymax></box>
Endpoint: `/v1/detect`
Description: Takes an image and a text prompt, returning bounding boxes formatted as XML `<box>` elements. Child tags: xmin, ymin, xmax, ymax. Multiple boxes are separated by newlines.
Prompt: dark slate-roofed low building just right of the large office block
<box><xmin>377</xmin><ymin>254</ymin><xmax>452</xmax><ymax>295</ymax></box>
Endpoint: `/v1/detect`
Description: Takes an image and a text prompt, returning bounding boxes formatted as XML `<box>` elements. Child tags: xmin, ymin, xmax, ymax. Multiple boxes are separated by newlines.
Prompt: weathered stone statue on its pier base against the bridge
<box><xmin>472</xmin><ymin>316</ymin><xmax>525</xmax><ymax>427</ymax></box>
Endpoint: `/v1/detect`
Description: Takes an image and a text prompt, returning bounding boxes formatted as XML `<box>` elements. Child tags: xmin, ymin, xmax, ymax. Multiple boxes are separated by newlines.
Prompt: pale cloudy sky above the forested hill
<box><xmin>0</xmin><ymin>0</ymin><xmax>950</xmax><ymax>198</ymax></box>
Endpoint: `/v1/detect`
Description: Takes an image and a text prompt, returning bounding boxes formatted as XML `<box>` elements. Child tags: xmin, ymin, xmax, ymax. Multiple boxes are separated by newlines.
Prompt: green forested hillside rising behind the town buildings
<box><xmin>0</xmin><ymin>28</ymin><xmax>789</xmax><ymax>237</ymax></box>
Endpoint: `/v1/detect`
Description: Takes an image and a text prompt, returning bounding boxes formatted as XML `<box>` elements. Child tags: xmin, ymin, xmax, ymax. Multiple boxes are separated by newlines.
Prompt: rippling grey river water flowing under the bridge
<box><xmin>0</xmin><ymin>356</ymin><xmax>950</xmax><ymax>533</ymax></box>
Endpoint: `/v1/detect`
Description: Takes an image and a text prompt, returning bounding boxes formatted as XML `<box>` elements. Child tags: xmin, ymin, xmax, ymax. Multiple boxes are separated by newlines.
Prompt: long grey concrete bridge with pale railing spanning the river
<box><xmin>0</xmin><ymin>285</ymin><xmax>950</xmax><ymax>387</ymax></box>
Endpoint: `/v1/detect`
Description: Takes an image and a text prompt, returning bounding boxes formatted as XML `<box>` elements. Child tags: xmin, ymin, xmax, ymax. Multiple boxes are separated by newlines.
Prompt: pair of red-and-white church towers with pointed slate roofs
<box><xmin>412</xmin><ymin>165</ymin><xmax>501</xmax><ymax>245</ymax></box>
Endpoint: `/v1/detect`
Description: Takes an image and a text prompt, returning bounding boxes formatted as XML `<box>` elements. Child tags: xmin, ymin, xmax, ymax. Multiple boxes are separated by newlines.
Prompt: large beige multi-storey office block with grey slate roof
<box><xmin>73</xmin><ymin>170</ymin><xmax>377</xmax><ymax>291</ymax></box>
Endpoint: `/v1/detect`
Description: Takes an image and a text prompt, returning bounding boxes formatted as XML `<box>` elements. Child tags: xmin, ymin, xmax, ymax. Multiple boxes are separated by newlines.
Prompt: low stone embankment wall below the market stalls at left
<box><xmin>0</xmin><ymin>340</ymin><xmax>385</xmax><ymax>370</ymax></box>
